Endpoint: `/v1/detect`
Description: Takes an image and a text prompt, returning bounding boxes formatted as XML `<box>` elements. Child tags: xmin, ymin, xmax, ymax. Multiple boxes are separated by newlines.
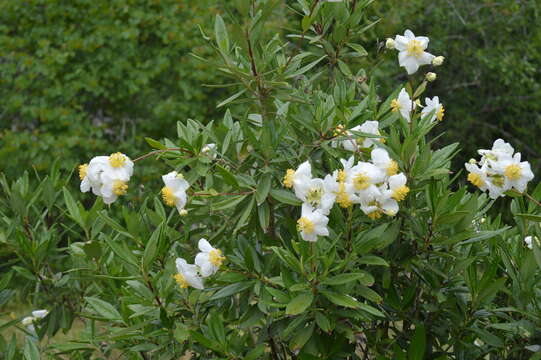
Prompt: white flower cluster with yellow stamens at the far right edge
<box><xmin>465</xmin><ymin>139</ymin><xmax>534</xmax><ymax>199</ymax></box>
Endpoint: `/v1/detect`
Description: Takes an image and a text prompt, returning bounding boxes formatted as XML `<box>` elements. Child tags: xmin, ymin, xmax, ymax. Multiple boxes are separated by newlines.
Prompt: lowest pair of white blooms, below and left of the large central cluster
<box><xmin>174</xmin><ymin>239</ymin><xmax>225</xmax><ymax>289</ymax></box>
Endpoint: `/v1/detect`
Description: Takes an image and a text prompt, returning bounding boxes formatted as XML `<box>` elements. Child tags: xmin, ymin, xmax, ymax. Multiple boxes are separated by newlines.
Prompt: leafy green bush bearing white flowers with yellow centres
<box><xmin>0</xmin><ymin>0</ymin><xmax>541</xmax><ymax>360</ymax></box>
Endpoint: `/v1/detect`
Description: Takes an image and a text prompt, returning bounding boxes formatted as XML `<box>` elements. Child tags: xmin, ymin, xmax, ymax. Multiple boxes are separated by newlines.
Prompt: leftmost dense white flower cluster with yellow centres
<box><xmin>79</xmin><ymin>152</ymin><xmax>133</xmax><ymax>204</ymax></box>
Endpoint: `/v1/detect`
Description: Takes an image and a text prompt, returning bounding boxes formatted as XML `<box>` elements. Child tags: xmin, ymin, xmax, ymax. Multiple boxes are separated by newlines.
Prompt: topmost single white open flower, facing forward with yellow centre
<box><xmin>394</xmin><ymin>30</ymin><xmax>435</xmax><ymax>75</ymax></box>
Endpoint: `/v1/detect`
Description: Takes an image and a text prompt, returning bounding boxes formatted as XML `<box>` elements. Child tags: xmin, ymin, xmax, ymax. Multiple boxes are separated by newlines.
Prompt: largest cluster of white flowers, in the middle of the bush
<box><xmin>284</xmin><ymin>148</ymin><xmax>410</xmax><ymax>241</ymax></box>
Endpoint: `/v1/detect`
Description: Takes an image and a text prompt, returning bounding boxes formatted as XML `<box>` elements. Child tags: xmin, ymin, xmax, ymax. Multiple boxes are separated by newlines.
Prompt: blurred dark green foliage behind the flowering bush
<box><xmin>0</xmin><ymin>0</ymin><xmax>541</xmax><ymax>178</ymax></box>
